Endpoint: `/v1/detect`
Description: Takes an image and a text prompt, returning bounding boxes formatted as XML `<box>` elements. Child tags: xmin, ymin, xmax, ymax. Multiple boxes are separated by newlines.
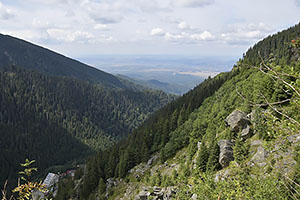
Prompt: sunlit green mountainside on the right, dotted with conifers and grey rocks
<box><xmin>56</xmin><ymin>24</ymin><xmax>300</xmax><ymax>199</ymax></box>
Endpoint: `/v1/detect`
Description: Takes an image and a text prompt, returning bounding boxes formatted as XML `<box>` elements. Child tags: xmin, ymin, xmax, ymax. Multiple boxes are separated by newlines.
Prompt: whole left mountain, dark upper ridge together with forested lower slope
<box><xmin>0</xmin><ymin>35</ymin><xmax>175</xmax><ymax>194</ymax></box>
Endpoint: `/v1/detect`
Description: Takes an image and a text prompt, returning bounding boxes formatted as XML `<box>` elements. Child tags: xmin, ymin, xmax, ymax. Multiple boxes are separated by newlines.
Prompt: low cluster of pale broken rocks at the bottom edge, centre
<box><xmin>134</xmin><ymin>186</ymin><xmax>176</xmax><ymax>200</ymax></box>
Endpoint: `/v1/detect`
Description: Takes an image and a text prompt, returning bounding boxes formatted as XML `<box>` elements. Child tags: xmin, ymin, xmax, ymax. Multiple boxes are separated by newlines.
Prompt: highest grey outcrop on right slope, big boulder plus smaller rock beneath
<box><xmin>225</xmin><ymin>110</ymin><xmax>252</xmax><ymax>138</ymax></box>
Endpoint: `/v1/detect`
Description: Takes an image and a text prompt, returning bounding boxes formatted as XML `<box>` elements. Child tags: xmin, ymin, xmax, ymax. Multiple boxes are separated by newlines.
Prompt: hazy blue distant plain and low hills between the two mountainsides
<box><xmin>78</xmin><ymin>55</ymin><xmax>238</xmax><ymax>94</ymax></box>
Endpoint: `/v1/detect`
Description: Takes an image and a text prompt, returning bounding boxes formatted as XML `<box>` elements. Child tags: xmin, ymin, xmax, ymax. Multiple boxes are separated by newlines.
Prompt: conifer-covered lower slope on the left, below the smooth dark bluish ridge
<box><xmin>0</xmin><ymin>66</ymin><xmax>174</xmax><ymax>193</ymax></box>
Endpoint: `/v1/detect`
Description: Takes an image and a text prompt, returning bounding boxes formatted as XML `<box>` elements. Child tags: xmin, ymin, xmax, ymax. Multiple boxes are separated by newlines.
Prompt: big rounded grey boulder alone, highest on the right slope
<box><xmin>225</xmin><ymin>110</ymin><xmax>250</xmax><ymax>132</ymax></box>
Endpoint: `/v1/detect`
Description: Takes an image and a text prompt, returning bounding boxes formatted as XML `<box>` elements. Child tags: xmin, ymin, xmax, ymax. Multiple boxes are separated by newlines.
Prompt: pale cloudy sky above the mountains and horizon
<box><xmin>0</xmin><ymin>0</ymin><xmax>300</xmax><ymax>57</ymax></box>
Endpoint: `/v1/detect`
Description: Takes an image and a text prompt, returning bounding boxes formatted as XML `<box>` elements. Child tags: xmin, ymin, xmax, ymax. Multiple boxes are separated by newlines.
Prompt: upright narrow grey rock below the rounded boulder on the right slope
<box><xmin>218</xmin><ymin>140</ymin><xmax>234</xmax><ymax>168</ymax></box>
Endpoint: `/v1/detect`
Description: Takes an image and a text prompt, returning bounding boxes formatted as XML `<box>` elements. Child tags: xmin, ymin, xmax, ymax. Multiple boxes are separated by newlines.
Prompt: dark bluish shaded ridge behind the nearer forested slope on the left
<box><xmin>0</xmin><ymin>34</ymin><xmax>126</xmax><ymax>88</ymax></box>
